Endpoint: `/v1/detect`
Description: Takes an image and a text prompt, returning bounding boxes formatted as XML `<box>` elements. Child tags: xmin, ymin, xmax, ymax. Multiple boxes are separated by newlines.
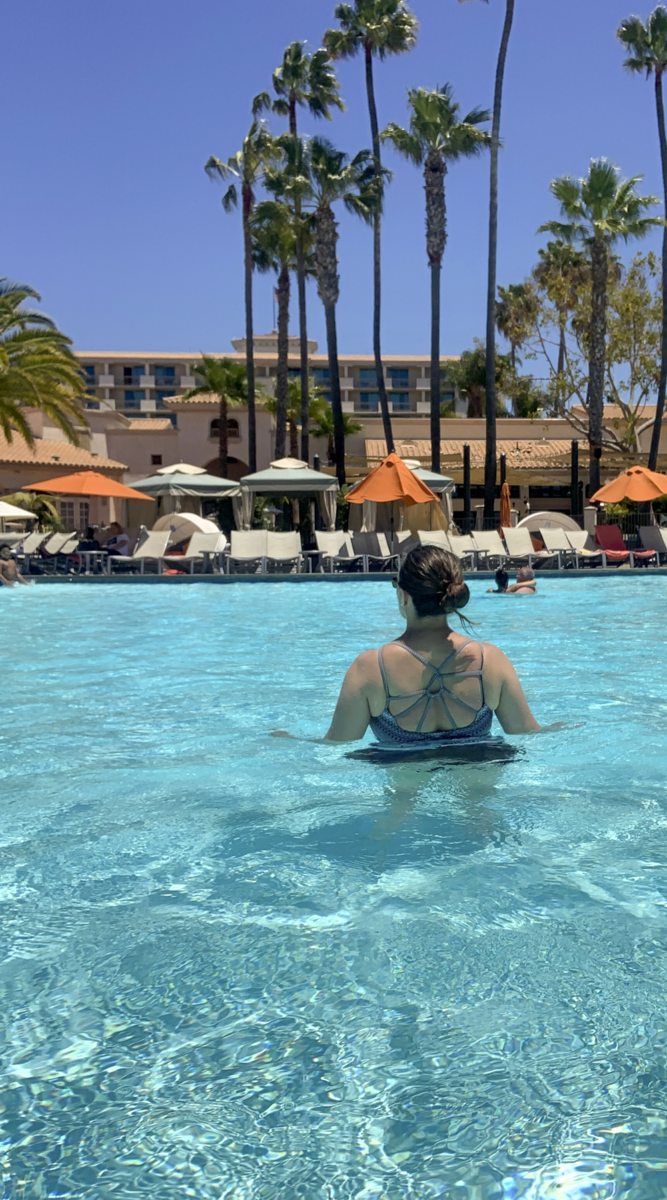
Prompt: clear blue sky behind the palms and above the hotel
<box><xmin>0</xmin><ymin>0</ymin><xmax>662</xmax><ymax>354</ymax></box>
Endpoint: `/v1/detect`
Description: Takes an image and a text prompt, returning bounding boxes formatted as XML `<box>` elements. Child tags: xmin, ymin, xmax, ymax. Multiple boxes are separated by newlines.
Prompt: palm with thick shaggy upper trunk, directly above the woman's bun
<box><xmin>380</xmin><ymin>83</ymin><xmax>491</xmax><ymax>472</ymax></box>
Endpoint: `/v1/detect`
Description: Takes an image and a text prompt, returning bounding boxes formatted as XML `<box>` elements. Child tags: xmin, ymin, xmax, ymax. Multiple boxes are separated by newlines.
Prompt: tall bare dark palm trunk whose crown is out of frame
<box><xmin>483</xmin><ymin>0</ymin><xmax>515</xmax><ymax>521</ymax></box>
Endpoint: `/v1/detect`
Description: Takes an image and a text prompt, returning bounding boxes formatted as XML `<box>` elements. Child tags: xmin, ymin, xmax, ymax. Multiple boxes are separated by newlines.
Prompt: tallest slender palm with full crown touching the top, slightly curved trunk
<box><xmin>324</xmin><ymin>0</ymin><xmax>417</xmax><ymax>454</ymax></box>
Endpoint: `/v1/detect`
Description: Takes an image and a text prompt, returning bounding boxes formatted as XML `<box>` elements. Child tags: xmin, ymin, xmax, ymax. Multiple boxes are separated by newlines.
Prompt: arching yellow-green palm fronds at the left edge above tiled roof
<box><xmin>0</xmin><ymin>278</ymin><xmax>85</xmax><ymax>445</ymax></box>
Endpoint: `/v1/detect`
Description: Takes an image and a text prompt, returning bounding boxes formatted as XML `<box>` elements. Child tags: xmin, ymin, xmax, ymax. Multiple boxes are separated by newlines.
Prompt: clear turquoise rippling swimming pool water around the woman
<box><xmin>0</xmin><ymin>572</ymin><xmax>667</xmax><ymax>1200</ymax></box>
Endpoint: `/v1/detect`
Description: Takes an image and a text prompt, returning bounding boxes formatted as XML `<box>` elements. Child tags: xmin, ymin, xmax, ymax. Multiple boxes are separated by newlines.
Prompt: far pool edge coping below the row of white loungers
<box><xmin>30</xmin><ymin>565</ymin><xmax>667</xmax><ymax>587</ymax></box>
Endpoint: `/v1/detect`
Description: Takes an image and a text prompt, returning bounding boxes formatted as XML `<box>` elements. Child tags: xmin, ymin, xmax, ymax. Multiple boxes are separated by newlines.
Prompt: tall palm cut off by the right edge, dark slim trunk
<box><xmin>617</xmin><ymin>5</ymin><xmax>667</xmax><ymax>470</ymax></box>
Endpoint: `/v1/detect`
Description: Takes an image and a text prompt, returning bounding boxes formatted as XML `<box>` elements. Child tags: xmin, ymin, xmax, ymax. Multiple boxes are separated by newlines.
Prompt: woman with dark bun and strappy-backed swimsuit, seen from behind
<box><xmin>325</xmin><ymin>546</ymin><xmax>549</xmax><ymax>748</ymax></box>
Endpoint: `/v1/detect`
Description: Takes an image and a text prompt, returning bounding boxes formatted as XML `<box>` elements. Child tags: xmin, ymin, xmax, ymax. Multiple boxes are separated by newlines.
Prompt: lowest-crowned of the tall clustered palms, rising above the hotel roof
<box><xmin>250</xmin><ymin>200</ymin><xmax>296</xmax><ymax>458</ymax></box>
